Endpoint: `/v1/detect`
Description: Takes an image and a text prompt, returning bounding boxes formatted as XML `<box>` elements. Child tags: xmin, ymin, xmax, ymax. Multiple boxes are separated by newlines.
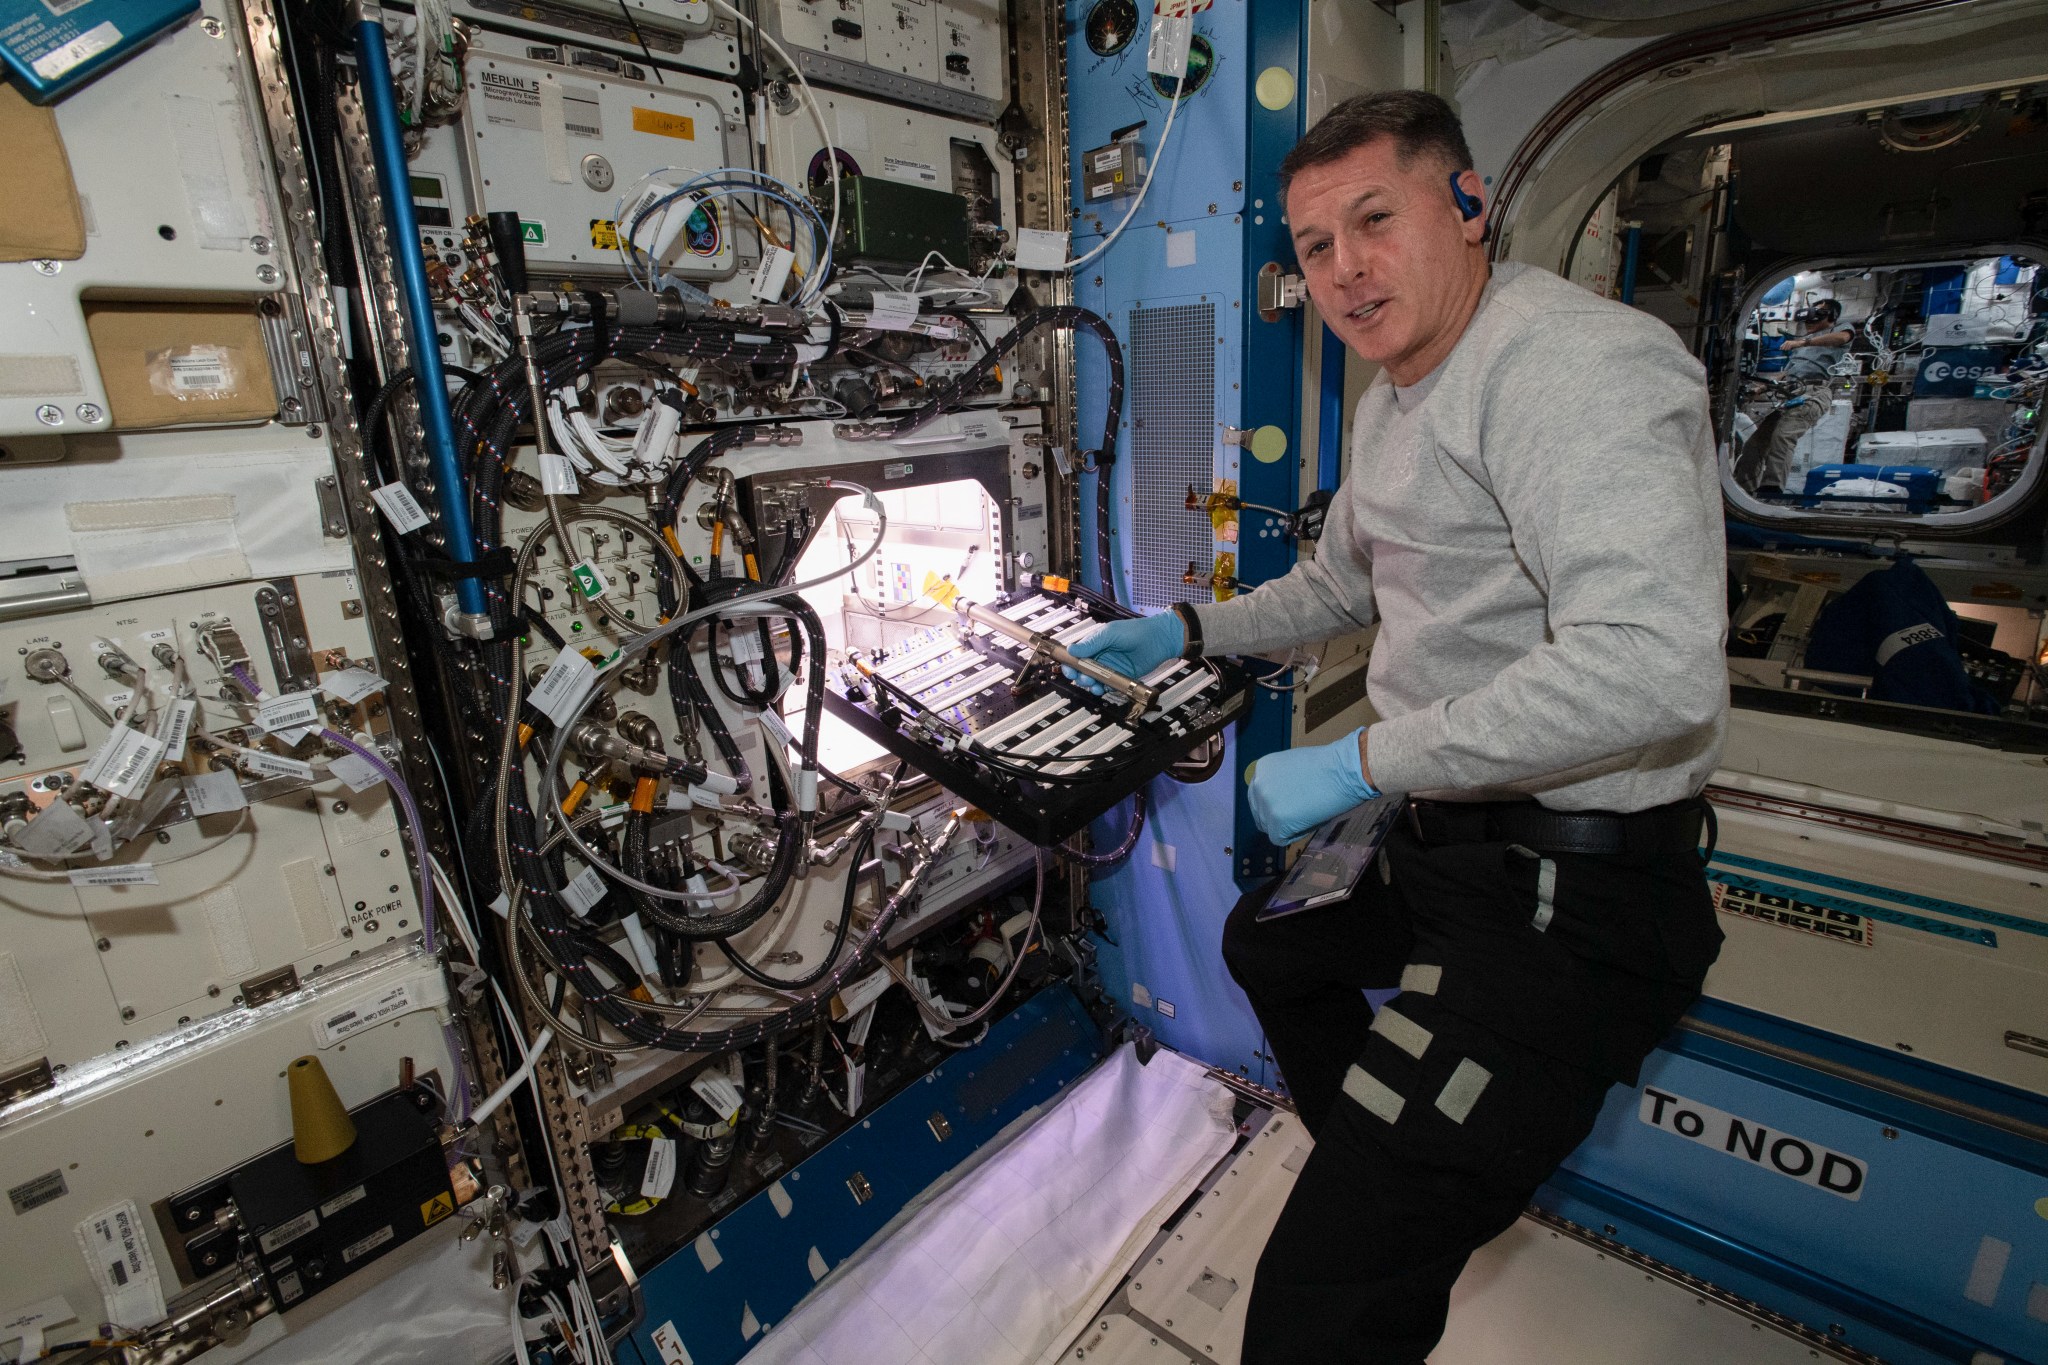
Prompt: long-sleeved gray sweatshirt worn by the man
<box><xmin>1198</xmin><ymin>264</ymin><xmax>1729</xmax><ymax>810</ymax></box>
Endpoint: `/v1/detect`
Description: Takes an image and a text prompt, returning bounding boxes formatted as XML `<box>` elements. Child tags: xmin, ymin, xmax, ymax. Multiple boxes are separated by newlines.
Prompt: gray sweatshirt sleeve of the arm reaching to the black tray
<box><xmin>1194</xmin><ymin>409</ymin><xmax>1374</xmax><ymax>655</ymax></box>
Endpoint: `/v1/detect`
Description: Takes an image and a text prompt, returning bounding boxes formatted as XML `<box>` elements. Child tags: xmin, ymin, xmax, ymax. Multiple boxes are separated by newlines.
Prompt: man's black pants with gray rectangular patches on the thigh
<box><xmin>1223</xmin><ymin>831</ymin><xmax>1720</xmax><ymax>1365</ymax></box>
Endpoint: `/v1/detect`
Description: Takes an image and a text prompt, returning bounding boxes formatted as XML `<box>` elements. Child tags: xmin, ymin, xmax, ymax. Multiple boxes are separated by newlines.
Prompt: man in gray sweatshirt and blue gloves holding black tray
<box><xmin>1077</xmin><ymin>90</ymin><xmax>1729</xmax><ymax>1365</ymax></box>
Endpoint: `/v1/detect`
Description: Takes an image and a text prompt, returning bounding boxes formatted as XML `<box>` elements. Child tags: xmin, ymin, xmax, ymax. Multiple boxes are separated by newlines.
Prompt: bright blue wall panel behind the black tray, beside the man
<box><xmin>1067</xmin><ymin>0</ymin><xmax>1294</xmax><ymax>1085</ymax></box>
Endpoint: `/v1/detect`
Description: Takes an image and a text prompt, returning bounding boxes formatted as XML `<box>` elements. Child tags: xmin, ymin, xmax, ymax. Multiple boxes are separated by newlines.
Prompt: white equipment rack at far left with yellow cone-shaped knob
<box><xmin>0</xmin><ymin>0</ymin><xmax>495</xmax><ymax>1361</ymax></box>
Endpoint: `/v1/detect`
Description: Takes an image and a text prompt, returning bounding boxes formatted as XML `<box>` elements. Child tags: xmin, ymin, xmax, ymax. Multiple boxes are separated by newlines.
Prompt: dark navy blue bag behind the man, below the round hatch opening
<box><xmin>1806</xmin><ymin>559</ymin><xmax>1999</xmax><ymax>716</ymax></box>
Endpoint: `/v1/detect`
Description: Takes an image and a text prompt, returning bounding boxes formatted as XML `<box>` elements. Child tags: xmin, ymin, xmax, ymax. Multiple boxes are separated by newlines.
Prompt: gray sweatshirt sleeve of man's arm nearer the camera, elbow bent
<box><xmin>1366</xmin><ymin>311</ymin><xmax>1729</xmax><ymax>792</ymax></box>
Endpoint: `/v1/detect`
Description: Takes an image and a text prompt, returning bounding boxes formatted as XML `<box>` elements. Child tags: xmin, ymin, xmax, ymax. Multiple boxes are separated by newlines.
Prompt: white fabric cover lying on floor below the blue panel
<box><xmin>743</xmin><ymin>1046</ymin><xmax>1235</xmax><ymax>1365</ymax></box>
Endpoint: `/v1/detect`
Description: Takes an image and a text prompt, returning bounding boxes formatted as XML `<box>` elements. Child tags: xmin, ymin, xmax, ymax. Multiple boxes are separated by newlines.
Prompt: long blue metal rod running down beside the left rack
<box><xmin>352</xmin><ymin>0</ymin><xmax>487</xmax><ymax>630</ymax></box>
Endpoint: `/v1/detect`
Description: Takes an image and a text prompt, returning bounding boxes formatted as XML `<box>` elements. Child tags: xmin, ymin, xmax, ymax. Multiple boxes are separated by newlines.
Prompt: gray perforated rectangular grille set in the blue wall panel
<box><xmin>1128</xmin><ymin>303</ymin><xmax>1217</xmax><ymax>610</ymax></box>
